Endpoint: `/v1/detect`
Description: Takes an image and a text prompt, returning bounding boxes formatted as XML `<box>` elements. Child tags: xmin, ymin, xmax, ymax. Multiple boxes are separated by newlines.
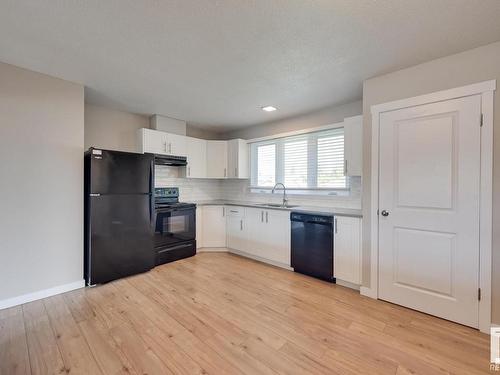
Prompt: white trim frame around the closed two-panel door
<box><xmin>360</xmin><ymin>80</ymin><xmax>496</xmax><ymax>333</ymax></box>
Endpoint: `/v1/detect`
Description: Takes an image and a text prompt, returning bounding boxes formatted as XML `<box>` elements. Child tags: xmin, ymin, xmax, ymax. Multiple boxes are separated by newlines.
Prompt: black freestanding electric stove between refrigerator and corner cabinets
<box><xmin>154</xmin><ymin>187</ymin><xmax>196</xmax><ymax>265</ymax></box>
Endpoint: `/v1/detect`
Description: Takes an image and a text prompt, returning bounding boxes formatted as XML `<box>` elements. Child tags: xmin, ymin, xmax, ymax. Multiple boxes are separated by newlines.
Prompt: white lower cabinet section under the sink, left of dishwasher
<box><xmin>227</xmin><ymin>206</ymin><xmax>290</xmax><ymax>266</ymax></box>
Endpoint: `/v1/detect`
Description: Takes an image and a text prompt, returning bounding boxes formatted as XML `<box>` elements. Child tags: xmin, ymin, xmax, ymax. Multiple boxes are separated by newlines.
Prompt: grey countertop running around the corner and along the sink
<box><xmin>192</xmin><ymin>199</ymin><xmax>363</xmax><ymax>217</ymax></box>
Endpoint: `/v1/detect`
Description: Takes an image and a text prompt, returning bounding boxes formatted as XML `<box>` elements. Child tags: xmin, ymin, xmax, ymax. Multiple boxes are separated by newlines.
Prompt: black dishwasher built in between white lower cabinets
<box><xmin>290</xmin><ymin>212</ymin><xmax>335</xmax><ymax>283</ymax></box>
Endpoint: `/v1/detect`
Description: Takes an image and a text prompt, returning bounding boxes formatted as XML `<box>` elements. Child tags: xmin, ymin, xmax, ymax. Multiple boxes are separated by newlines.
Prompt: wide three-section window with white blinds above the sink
<box><xmin>250</xmin><ymin>128</ymin><xmax>348</xmax><ymax>192</ymax></box>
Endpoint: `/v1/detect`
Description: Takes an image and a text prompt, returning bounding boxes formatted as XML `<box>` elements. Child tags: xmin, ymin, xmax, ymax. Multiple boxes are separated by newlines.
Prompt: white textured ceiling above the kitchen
<box><xmin>0</xmin><ymin>0</ymin><xmax>500</xmax><ymax>131</ymax></box>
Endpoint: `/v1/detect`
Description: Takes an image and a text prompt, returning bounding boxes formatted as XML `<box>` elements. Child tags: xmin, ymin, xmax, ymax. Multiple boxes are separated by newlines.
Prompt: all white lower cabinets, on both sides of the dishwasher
<box><xmin>196</xmin><ymin>205</ymin><xmax>361</xmax><ymax>285</ymax></box>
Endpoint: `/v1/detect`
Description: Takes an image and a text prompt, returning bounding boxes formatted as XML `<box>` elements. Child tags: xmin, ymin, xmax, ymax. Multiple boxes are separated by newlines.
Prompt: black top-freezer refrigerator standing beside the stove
<box><xmin>84</xmin><ymin>148</ymin><xmax>155</xmax><ymax>285</ymax></box>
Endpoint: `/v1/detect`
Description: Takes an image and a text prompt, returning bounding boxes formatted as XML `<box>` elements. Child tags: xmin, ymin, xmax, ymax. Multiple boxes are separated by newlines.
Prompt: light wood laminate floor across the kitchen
<box><xmin>0</xmin><ymin>253</ymin><xmax>490</xmax><ymax>375</ymax></box>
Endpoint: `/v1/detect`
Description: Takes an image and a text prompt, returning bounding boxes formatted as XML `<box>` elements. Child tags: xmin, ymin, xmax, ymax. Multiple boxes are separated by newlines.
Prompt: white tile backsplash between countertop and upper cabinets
<box><xmin>155</xmin><ymin>166</ymin><xmax>361</xmax><ymax>208</ymax></box>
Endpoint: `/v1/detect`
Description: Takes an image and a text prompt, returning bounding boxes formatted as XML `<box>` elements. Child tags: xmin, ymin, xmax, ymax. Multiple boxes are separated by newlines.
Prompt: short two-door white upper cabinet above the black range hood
<box><xmin>137</xmin><ymin>129</ymin><xmax>187</xmax><ymax>156</ymax></box>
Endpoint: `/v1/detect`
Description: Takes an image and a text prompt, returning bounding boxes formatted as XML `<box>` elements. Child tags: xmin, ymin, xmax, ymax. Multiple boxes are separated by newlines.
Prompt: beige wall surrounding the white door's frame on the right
<box><xmin>363</xmin><ymin>42</ymin><xmax>500</xmax><ymax>323</ymax></box>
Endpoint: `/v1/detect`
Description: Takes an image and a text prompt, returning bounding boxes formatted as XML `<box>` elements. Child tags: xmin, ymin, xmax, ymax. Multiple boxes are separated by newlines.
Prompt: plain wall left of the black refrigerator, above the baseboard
<box><xmin>0</xmin><ymin>63</ymin><xmax>84</xmax><ymax>305</ymax></box>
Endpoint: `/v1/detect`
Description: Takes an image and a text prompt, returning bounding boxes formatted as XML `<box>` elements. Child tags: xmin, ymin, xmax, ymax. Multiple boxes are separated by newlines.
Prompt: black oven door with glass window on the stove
<box><xmin>155</xmin><ymin>209</ymin><xmax>196</xmax><ymax>246</ymax></box>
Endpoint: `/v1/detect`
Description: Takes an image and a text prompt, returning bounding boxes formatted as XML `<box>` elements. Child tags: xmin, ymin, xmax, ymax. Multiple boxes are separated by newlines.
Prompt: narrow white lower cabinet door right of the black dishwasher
<box><xmin>333</xmin><ymin>216</ymin><xmax>361</xmax><ymax>285</ymax></box>
